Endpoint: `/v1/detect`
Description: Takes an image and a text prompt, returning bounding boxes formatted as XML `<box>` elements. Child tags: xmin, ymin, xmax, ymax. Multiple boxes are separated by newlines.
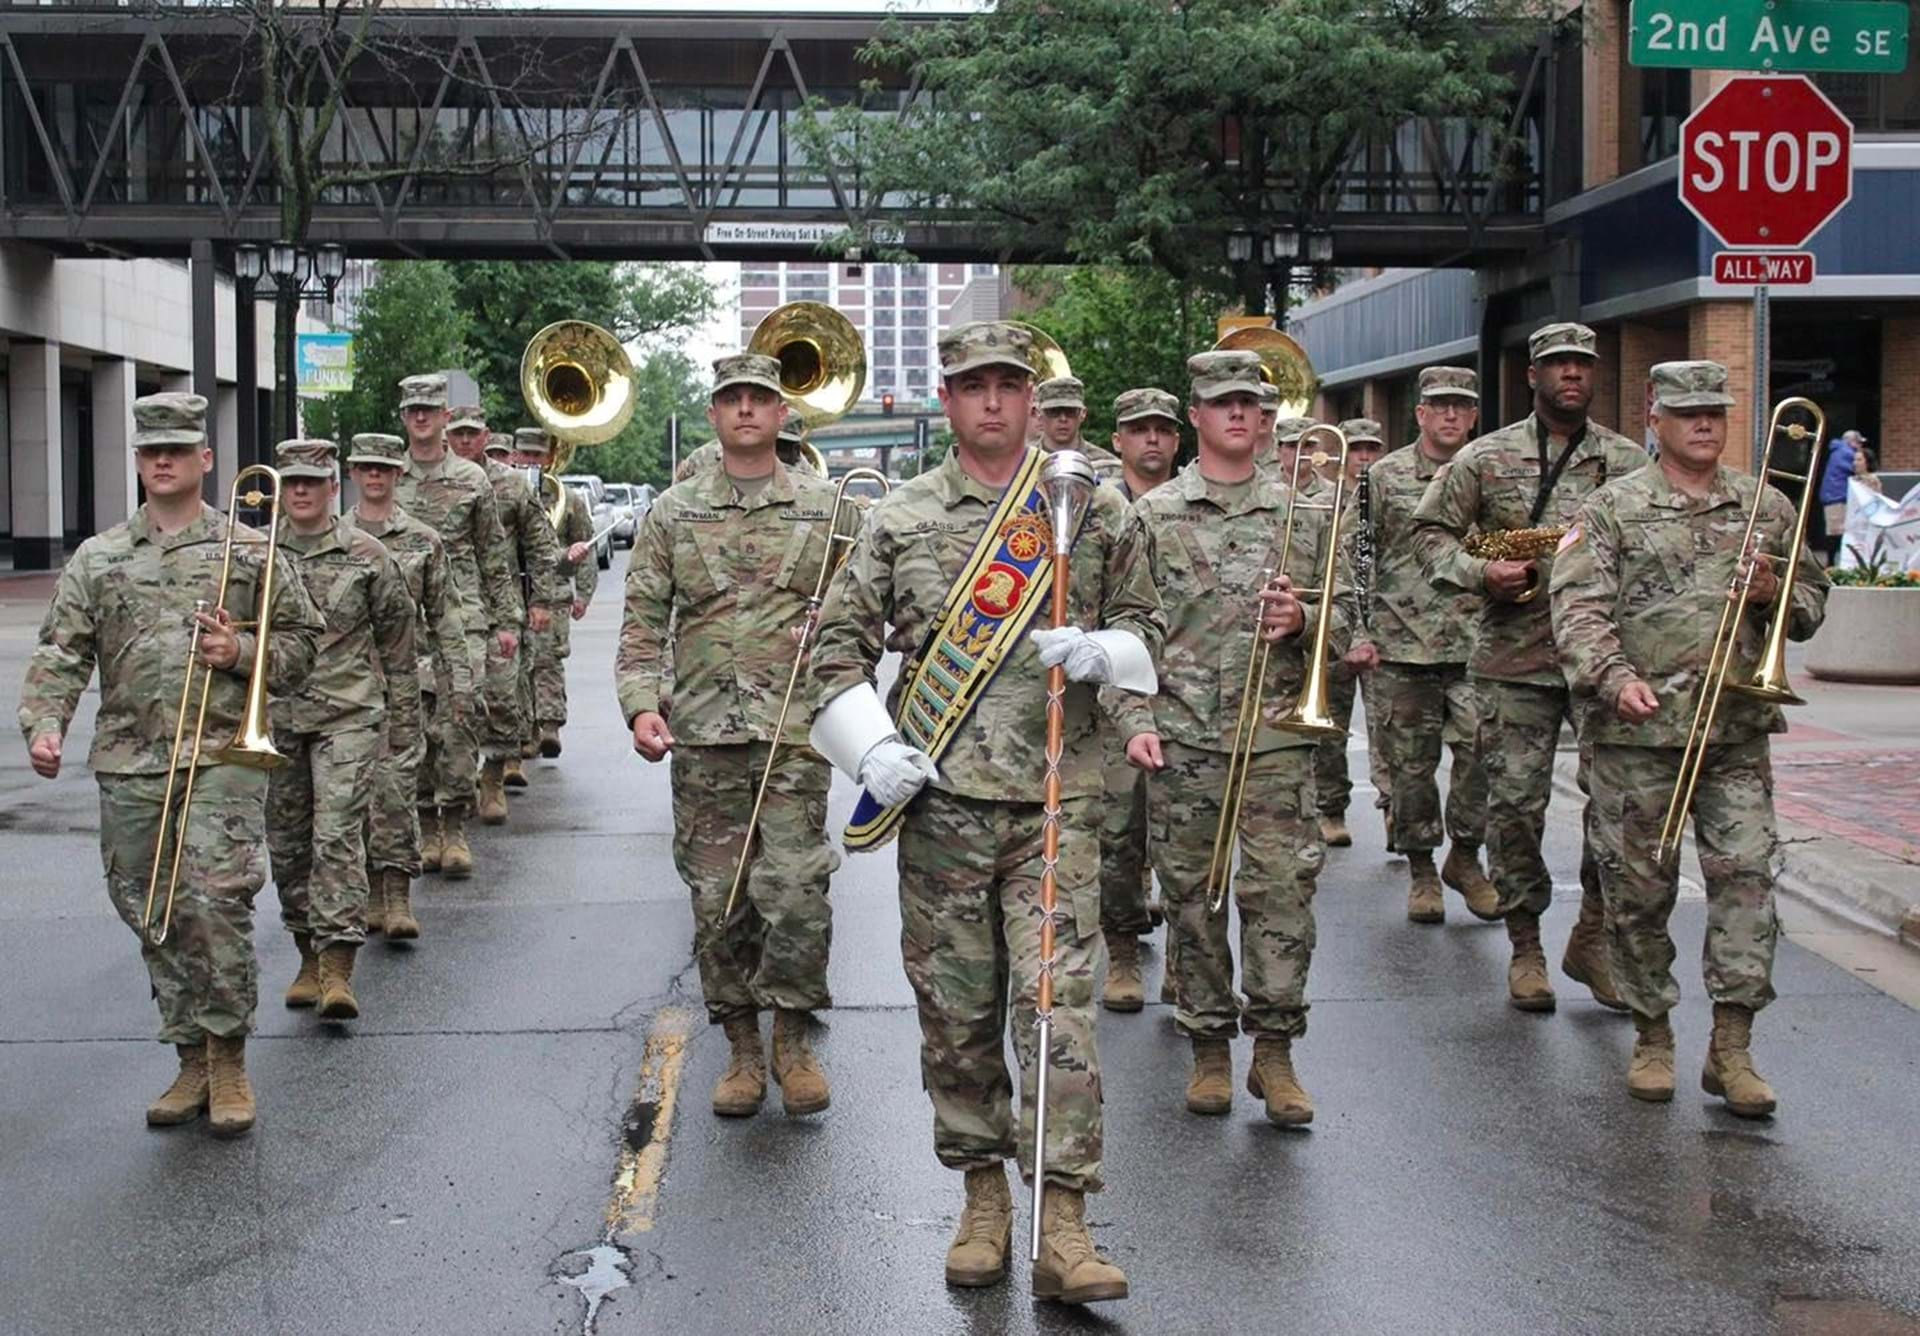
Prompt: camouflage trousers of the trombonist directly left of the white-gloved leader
<box><xmin>674</xmin><ymin>743</ymin><xmax>839</xmax><ymax>1025</ymax></box>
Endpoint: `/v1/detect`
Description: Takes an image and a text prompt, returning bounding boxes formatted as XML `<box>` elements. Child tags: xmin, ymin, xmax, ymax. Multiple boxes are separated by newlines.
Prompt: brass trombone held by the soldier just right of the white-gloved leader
<box><xmin>1206</xmin><ymin>424</ymin><xmax>1346</xmax><ymax>914</ymax></box>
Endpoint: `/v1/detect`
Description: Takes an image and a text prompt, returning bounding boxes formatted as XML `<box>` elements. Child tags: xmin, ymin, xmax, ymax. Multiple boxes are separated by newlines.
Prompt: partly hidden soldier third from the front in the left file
<box><xmin>340</xmin><ymin>432</ymin><xmax>474</xmax><ymax>942</ymax></box>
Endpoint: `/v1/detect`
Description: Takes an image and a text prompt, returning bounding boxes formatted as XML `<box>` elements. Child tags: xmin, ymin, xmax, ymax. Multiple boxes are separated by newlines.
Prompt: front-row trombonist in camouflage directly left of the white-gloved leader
<box><xmin>614</xmin><ymin>353</ymin><xmax>839</xmax><ymax>1117</ymax></box>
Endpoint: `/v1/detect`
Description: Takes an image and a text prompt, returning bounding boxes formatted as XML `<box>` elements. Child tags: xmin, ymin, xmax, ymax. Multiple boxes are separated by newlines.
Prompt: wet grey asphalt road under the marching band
<box><xmin>0</xmin><ymin>548</ymin><xmax>1920</xmax><ymax>1336</ymax></box>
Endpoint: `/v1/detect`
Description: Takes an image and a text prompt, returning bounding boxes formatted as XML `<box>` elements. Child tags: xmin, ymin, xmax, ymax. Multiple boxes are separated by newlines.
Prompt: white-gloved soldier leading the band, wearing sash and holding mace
<box><xmin>812</xmin><ymin>322</ymin><xmax>1160</xmax><ymax>1303</ymax></box>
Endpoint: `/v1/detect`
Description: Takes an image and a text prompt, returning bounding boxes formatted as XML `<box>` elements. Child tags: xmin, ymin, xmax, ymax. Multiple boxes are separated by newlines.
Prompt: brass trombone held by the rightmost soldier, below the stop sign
<box><xmin>1655</xmin><ymin>397</ymin><xmax>1826</xmax><ymax>864</ymax></box>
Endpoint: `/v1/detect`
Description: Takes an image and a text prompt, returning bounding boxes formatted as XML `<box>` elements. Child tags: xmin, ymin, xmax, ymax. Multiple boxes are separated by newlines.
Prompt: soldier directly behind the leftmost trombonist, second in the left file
<box><xmin>267</xmin><ymin>440</ymin><xmax>420</xmax><ymax>1021</ymax></box>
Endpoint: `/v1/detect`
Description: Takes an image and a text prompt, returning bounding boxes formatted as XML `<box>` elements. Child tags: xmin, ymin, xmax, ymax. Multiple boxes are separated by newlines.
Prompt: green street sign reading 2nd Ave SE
<box><xmin>1628</xmin><ymin>0</ymin><xmax>1908</xmax><ymax>75</ymax></box>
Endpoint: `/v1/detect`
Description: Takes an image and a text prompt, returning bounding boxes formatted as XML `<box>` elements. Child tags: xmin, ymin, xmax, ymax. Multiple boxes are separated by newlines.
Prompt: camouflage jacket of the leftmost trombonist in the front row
<box><xmin>19</xmin><ymin>505</ymin><xmax>323</xmax><ymax>775</ymax></box>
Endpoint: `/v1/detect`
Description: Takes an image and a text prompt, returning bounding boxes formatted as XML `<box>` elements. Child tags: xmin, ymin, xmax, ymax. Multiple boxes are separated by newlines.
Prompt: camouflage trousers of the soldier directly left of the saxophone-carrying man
<box><xmin>1369</xmin><ymin>662</ymin><xmax>1486</xmax><ymax>854</ymax></box>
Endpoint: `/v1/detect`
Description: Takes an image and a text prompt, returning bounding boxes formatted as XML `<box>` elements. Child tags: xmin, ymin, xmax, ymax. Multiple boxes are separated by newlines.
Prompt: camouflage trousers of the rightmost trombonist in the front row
<box><xmin>1594</xmin><ymin>737</ymin><xmax>1780</xmax><ymax>1015</ymax></box>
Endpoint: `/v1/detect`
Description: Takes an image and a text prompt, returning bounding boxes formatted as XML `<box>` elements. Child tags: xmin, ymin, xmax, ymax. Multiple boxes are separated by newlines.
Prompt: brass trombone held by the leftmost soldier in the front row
<box><xmin>140</xmin><ymin>465</ymin><xmax>286</xmax><ymax>946</ymax></box>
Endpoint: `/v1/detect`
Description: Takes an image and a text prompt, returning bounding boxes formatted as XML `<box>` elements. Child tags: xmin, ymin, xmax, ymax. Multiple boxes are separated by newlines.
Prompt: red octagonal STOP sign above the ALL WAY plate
<box><xmin>1680</xmin><ymin>75</ymin><xmax>1853</xmax><ymax>250</ymax></box>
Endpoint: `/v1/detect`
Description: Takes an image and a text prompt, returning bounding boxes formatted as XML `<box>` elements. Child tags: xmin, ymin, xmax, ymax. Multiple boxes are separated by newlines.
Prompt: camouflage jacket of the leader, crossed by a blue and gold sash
<box><xmin>812</xmin><ymin>449</ymin><xmax>1164</xmax><ymax>802</ymax></box>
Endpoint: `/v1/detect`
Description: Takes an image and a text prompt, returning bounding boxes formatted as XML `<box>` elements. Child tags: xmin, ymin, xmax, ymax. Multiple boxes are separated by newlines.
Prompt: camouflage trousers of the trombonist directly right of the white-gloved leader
<box><xmin>1146</xmin><ymin>741</ymin><xmax>1327</xmax><ymax>1038</ymax></box>
